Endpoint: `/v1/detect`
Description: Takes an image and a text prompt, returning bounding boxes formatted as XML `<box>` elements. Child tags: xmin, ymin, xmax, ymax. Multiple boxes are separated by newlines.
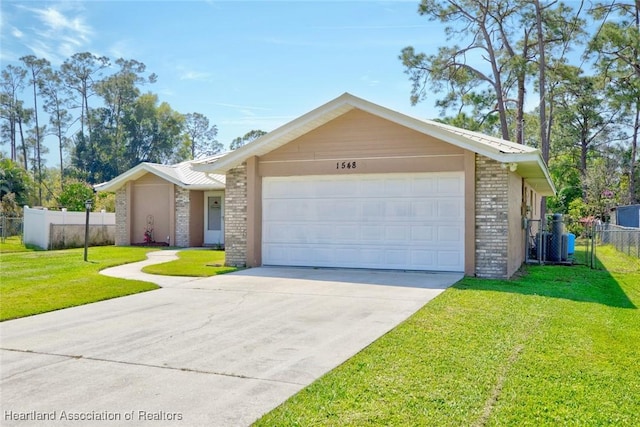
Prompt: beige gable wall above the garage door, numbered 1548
<box><xmin>258</xmin><ymin>110</ymin><xmax>464</xmax><ymax>176</ymax></box>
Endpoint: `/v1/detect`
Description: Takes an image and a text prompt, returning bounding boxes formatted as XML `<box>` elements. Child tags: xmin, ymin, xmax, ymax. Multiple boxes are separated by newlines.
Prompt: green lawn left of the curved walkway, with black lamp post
<box><xmin>0</xmin><ymin>247</ymin><xmax>158</xmax><ymax>320</ymax></box>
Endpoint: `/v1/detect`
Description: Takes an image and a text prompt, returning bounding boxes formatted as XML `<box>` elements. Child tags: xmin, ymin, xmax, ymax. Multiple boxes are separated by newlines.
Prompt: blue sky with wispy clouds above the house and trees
<box><xmin>0</xmin><ymin>0</ymin><xmax>444</xmax><ymax>166</ymax></box>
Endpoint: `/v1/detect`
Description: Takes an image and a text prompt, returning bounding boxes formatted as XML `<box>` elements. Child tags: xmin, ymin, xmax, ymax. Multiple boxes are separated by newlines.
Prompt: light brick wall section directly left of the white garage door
<box><xmin>224</xmin><ymin>163</ymin><xmax>247</xmax><ymax>267</ymax></box>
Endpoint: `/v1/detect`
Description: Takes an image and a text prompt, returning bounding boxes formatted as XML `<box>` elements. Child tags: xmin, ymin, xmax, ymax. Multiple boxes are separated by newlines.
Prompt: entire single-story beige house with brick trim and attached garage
<box><xmin>98</xmin><ymin>93</ymin><xmax>555</xmax><ymax>277</ymax></box>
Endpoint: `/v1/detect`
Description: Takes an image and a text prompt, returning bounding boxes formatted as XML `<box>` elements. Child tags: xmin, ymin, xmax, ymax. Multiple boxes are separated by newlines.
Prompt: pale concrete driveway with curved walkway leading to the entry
<box><xmin>0</xmin><ymin>251</ymin><xmax>462</xmax><ymax>426</ymax></box>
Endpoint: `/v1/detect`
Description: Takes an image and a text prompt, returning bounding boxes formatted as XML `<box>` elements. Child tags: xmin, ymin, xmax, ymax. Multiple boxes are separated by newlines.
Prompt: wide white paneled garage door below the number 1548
<box><xmin>262</xmin><ymin>172</ymin><xmax>464</xmax><ymax>271</ymax></box>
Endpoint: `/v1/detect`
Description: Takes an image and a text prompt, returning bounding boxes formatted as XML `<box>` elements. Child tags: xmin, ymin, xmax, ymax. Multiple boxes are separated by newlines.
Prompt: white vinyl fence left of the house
<box><xmin>23</xmin><ymin>206</ymin><xmax>116</xmax><ymax>249</ymax></box>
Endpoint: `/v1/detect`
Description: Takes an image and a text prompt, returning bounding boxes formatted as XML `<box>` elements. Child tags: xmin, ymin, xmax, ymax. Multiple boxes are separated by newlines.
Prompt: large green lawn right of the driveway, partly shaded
<box><xmin>256</xmin><ymin>247</ymin><xmax>640</xmax><ymax>426</ymax></box>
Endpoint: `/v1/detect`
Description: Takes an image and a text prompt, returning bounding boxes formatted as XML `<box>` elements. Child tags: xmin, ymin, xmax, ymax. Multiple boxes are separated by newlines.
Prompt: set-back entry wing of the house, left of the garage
<box><xmin>95</xmin><ymin>154</ymin><xmax>225</xmax><ymax>247</ymax></box>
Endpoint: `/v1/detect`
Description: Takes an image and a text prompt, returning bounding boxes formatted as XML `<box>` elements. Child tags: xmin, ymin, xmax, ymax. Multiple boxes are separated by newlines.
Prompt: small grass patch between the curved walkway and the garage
<box><xmin>142</xmin><ymin>249</ymin><xmax>237</xmax><ymax>277</ymax></box>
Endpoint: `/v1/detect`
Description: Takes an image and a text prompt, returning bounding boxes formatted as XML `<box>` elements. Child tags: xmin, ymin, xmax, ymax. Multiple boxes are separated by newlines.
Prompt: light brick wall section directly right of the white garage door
<box><xmin>475</xmin><ymin>155</ymin><xmax>509</xmax><ymax>278</ymax></box>
